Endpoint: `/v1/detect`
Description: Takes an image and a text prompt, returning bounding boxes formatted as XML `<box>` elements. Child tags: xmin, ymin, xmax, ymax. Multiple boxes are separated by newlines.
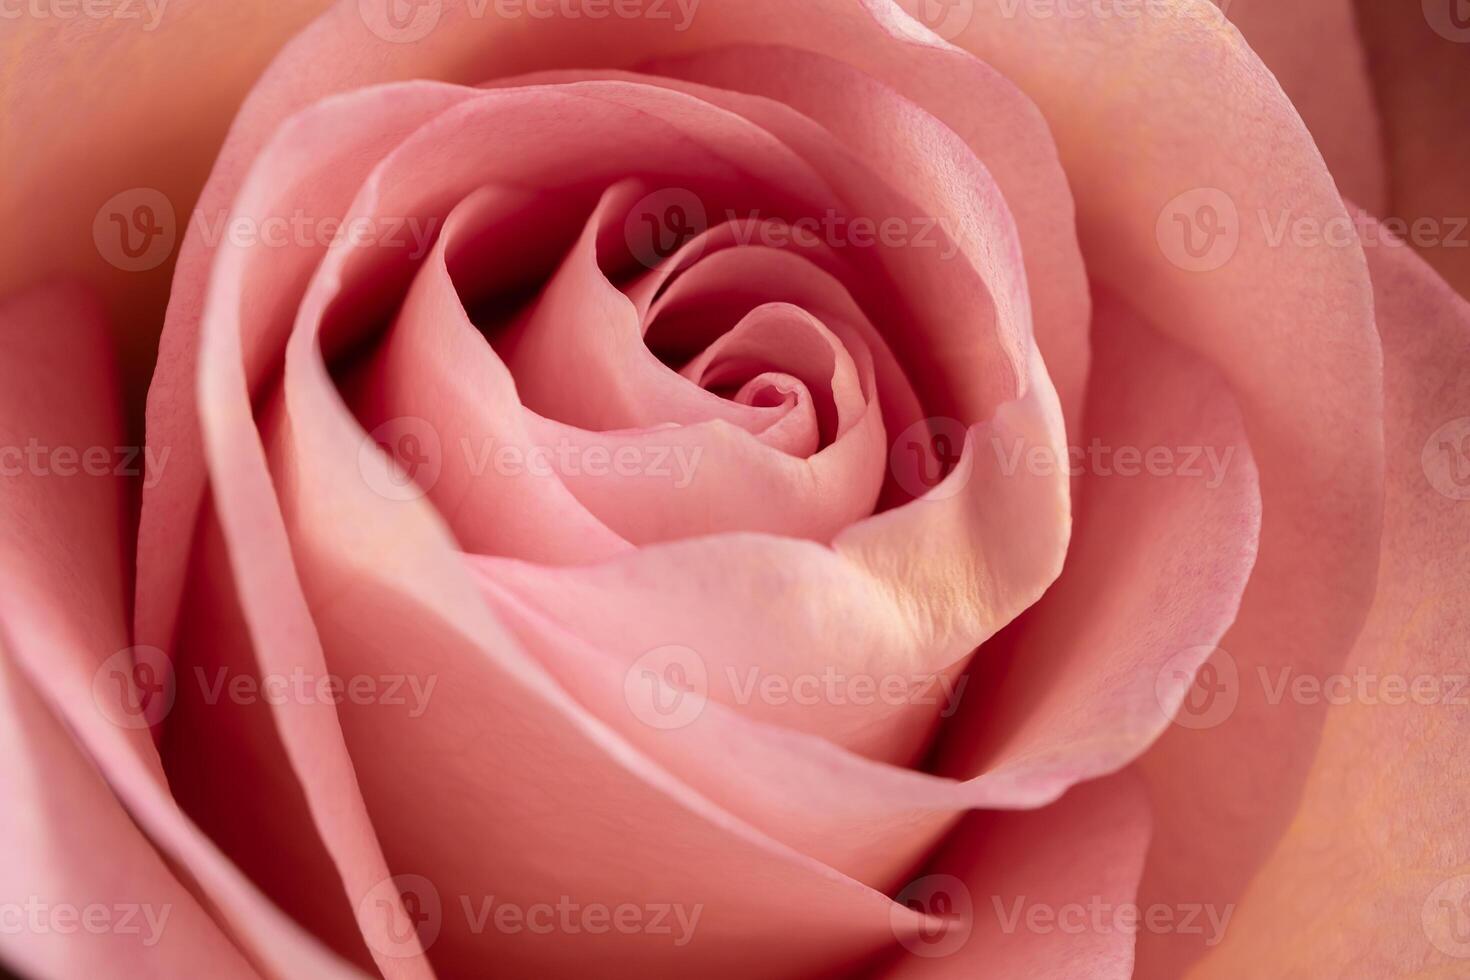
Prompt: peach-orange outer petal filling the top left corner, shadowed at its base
<box><xmin>0</xmin><ymin>0</ymin><xmax>333</xmax><ymax>395</ymax></box>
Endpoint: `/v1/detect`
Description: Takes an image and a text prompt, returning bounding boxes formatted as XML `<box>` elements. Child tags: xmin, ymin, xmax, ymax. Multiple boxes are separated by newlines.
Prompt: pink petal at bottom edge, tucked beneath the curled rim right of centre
<box><xmin>883</xmin><ymin>773</ymin><xmax>1150</xmax><ymax>980</ymax></box>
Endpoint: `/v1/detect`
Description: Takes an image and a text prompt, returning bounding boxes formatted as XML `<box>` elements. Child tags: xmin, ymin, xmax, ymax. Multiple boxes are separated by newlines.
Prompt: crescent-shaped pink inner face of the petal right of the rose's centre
<box><xmin>936</xmin><ymin>294</ymin><xmax>1261</xmax><ymax>785</ymax></box>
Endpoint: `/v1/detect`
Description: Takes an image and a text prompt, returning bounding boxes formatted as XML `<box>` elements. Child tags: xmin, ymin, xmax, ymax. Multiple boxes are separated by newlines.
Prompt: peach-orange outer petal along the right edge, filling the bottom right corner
<box><xmin>1192</xmin><ymin>227</ymin><xmax>1470</xmax><ymax>979</ymax></box>
